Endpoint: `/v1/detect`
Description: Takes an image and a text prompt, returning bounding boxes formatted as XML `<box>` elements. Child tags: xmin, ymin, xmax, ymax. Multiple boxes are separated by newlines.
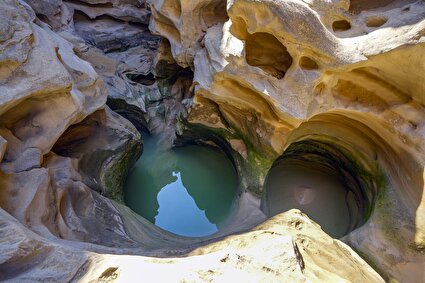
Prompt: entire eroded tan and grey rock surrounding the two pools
<box><xmin>0</xmin><ymin>0</ymin><xmax>425</xmax><ymax>282</ymax></box>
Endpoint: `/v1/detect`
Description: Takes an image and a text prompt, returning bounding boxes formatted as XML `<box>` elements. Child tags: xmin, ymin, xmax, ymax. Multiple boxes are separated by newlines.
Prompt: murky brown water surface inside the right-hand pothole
<box><xmin>266</xmin><ymin>161</ymin><xmax>352</xmax><ymax>238</ymax></box>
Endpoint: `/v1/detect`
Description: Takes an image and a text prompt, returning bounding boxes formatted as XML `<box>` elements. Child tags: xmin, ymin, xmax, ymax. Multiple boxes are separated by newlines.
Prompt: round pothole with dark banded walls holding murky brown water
<box><xmin>266</xmin><ymin>140</ymin><xmax>377</xmax><ymax>238</ymax></box>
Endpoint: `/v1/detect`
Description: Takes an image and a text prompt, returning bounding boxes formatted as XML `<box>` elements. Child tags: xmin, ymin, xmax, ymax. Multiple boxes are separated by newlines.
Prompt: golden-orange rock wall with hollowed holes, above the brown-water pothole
<box><xmin>150</xmin><ymin>0</ymin><xmax>425</xmax><ymax>282</ymax></box>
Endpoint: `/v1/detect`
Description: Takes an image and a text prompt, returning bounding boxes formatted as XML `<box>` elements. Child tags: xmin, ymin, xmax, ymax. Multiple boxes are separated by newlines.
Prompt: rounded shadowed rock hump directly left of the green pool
<box><xmin>53</xmin><ymin>107</ymin><xmax>142</xmax><ymax>202</ymax></box>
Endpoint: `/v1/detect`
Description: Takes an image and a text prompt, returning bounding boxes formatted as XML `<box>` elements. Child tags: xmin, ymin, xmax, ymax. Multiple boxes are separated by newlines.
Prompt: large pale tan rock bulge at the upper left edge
<box><xmin>0</xmin><ymin>1</ymin><xmax>106</xmax><ymax>172</ymax></box>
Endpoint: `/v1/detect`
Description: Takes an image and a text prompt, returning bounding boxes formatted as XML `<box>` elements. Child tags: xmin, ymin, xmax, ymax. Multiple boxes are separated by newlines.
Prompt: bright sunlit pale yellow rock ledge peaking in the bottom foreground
<box><xmin>80</xmin><ymin>210</ymin><xmax>384</xmax><ymax>282</ymax></box>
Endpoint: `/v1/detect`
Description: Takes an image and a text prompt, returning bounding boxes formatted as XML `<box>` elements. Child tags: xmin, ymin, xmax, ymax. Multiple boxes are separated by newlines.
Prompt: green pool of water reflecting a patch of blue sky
<box><xmin>124</xmin><ymin>134</ymin><xmax>238</xmax><ymax>237</ymax></box>
